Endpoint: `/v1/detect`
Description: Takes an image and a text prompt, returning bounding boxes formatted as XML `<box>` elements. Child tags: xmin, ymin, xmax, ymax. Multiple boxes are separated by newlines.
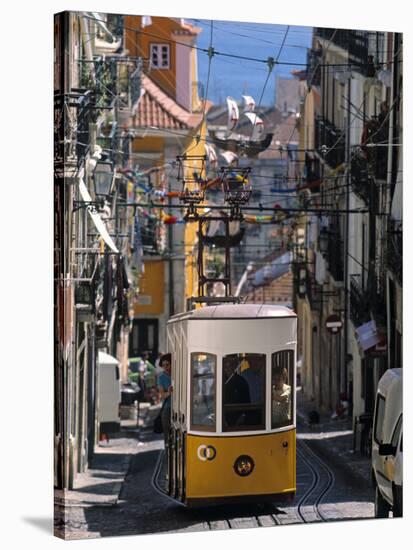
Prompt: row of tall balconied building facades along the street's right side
<box><xmin>295</xmin><ymin>28</ymin><xmax>402</xmax><ymax>440</ymax></box>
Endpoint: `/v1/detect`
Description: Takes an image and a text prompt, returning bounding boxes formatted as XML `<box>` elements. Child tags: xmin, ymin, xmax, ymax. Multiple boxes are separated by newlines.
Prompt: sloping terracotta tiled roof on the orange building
<box><xmin>133</xmin><ymin>74</ymin><xmax>202</xmax><ymax>130</ymax></box>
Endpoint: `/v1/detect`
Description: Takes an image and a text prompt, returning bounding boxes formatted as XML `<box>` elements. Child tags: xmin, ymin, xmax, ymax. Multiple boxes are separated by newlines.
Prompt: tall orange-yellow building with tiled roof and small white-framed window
<box><xmin>125</xmin><ymin>16</ymin><xmax>209</xmax><ymax>357</ymax></box>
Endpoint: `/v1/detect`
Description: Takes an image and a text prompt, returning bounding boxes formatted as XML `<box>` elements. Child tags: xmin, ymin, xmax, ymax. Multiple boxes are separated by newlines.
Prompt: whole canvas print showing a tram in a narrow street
<box><xmin>53</xmin><ymin>11</ymin><xmax>403</xmax><ymax>539</ymax></box>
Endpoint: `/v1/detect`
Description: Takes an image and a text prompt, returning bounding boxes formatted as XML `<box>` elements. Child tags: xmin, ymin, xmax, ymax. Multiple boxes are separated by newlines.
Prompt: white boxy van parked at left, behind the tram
<box><xmin>97</xmin><ymin>351</ymin><xmax>121</xmax><ymax>437</ymax></box>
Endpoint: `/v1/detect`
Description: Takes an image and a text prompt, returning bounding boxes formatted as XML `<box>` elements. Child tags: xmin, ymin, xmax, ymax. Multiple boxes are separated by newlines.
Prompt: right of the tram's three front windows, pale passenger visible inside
<box><xmin>271</xmin><ymin>350</ymin><xmax>294</xmax><ymax>428</ymax></box>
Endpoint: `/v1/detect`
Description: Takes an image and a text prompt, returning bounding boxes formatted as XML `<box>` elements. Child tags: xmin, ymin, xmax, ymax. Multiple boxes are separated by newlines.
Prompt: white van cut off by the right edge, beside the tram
<box><xmin>371</xmin><ymin>369</ymin><xmax>403</xmax><ymax>518</ymax></box>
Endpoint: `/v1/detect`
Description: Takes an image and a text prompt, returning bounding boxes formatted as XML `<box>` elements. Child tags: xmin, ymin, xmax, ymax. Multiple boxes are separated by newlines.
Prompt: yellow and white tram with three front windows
<box><xmin>167</xmin><ymin>304</ymin><xmax>297</xmax><ymax>506</ymax></box>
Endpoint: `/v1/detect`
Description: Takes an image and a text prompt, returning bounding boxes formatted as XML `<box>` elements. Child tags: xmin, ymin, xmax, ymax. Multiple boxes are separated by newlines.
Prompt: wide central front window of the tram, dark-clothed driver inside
<box><xmin>222</xmin><ymin>353</ymin><xmax>265</xmax><ymax>432</ymax></box>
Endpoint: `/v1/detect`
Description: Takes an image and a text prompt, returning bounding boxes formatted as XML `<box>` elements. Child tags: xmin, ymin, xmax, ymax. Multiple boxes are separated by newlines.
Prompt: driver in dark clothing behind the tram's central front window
<box><xmin>223</xmin><ymin>362</ymin><xmax>251</xmax><ymax>428</ymax></box>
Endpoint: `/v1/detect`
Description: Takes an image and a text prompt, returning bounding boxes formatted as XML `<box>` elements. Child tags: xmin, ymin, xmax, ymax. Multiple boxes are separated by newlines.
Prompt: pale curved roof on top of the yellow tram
<box><xmin>170</xmin><ymin>304</ymin><xmax>297</xmax><ymax>321</ymax></box>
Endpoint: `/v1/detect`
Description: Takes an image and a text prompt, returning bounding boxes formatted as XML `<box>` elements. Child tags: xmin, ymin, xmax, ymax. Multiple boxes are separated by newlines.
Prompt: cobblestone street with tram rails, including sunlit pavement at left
<box><xmin>55</xmin><ymin>392</ymin><xmax>374</xmax><ymax>539</ymax></box>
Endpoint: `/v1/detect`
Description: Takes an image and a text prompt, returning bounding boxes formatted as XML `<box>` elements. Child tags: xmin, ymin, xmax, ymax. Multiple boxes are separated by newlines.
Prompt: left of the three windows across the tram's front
<box><xmin>191</xmin><ymin>353</ymin><xmax>216</xmax><ymax>431</ymax></box>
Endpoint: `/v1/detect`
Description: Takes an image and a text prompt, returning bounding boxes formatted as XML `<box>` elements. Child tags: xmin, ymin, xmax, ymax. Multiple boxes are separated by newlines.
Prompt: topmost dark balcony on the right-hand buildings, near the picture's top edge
<box><xmin>315</xmin><ymin>27</ymin><xmax>370</xmax><ymax>76</ymax></box>
